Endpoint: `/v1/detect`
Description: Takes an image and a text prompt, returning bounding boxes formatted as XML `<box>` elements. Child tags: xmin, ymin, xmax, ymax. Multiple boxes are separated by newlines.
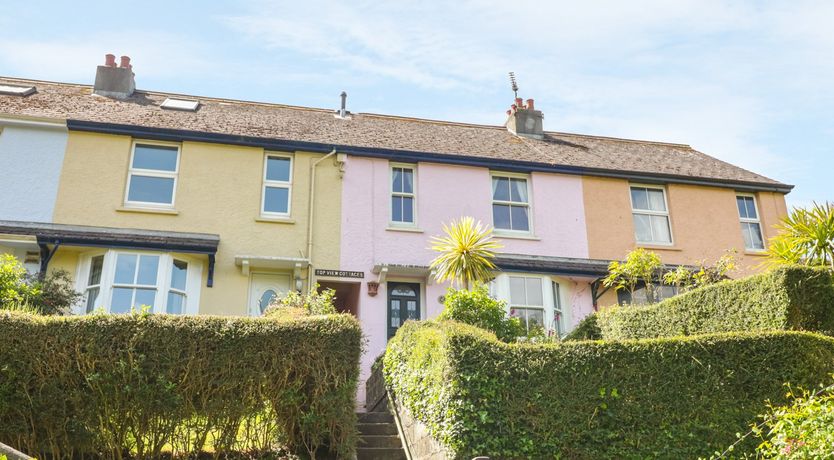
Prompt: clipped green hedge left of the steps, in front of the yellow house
<box><xmin>0</xmin><ymin>312</ymin><xmax>362</xmax><ymax>458</ymax></box>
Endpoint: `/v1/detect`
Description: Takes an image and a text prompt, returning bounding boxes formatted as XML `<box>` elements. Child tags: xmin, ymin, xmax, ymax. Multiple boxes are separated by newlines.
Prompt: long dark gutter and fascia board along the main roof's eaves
<box><xmin>67</xmin><ymin>120</ymin><xmax>794</xmax><ymax>193</ymax></box>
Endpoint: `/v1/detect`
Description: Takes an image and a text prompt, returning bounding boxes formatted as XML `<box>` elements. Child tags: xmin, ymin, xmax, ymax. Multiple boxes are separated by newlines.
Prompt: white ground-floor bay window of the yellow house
<box><xmin>77</xmin><ymin>250</ymin><xmax>202</xmax><ymax>314</ymax></box>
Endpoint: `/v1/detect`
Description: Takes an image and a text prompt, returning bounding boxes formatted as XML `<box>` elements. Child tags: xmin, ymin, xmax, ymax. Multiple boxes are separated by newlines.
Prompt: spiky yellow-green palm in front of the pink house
<box><xmin>431</xmin><ymin>217</ymin><xmax>502</xmax><ymax>290</ymax></box>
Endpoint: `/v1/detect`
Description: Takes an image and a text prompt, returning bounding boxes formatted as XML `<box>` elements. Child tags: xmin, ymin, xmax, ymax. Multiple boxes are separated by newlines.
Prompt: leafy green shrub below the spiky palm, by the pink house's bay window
<box><xmin>438</xmin><ymin>285</ymin><xmax>526</xmax><ymax>342</ymax></box>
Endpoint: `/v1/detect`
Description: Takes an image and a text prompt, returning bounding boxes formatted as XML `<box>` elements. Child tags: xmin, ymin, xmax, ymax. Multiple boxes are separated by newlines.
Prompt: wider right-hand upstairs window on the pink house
<box><xmin>491</xmin><ymin>172</ymin><xmax>532</xmax><ymax>234</ymax></box>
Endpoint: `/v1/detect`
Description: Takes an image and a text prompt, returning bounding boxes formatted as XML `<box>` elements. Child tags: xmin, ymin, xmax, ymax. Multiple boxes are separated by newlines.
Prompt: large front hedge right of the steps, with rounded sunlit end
<box><xmin>384</xmin><ymin>322</ymin><xmax>834</xmax><ymax>459</ymax></box>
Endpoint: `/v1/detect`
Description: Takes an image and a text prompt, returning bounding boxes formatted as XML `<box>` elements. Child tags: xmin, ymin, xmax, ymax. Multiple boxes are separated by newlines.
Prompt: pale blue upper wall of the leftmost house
<box><xmin>0</xmin><ymin>120</ymin><xmax>67</xmax><ymax>222</ymax></box>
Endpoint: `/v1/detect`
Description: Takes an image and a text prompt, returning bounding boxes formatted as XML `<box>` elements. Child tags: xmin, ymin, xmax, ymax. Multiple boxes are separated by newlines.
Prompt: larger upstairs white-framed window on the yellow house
<box><xmin>125</xmin><ymin>141</ymin><xmax>180</xmax><ymax>208</ymax></box>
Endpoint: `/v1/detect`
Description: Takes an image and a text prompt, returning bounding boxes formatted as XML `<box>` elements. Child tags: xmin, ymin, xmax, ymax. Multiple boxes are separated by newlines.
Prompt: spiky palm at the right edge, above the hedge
<box><xmin>767</xmin><ymin>203</ymin><xmax>834</xmax><ymax>270</ymax></box>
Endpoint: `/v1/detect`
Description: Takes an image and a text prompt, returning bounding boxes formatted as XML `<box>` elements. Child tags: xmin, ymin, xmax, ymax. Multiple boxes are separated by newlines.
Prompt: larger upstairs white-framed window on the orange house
<box><xmin>631</xmin><ymin>185</ymin><xmax>672</xmax><ymax>245</ymax></box>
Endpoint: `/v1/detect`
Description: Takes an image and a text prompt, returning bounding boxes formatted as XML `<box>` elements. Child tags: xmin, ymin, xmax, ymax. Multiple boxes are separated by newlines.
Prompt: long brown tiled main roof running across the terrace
<box><xmin>0</xmin><ymin>77</ymin><xmax>790</xmax><ymax>190</ymax></box>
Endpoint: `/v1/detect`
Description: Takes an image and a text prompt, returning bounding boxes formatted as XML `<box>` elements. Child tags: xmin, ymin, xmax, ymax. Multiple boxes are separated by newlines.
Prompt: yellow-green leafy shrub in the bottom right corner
<box><xmin>754</xmin><ymin>380</ymin><xmax>834</xmax><ymax>459</ymax></box>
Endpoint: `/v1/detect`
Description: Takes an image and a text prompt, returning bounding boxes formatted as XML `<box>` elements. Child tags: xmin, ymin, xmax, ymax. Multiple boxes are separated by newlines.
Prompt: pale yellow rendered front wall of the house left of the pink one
<box><xmin>54</xmin><ymin>132</ymin><xmax>341</xmax><ymax>315</ymax></box>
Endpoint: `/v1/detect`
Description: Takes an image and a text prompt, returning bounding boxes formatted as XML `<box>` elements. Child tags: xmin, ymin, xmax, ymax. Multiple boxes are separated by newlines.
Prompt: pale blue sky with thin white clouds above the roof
<box><xmin>0</xmin><ymin>0</ymin><xmax>834</xmax><ymax>205</ymax></box>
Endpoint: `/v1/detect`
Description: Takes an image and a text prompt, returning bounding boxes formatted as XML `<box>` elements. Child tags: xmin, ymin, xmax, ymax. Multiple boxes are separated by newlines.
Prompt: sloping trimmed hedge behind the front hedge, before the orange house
<box><xmin>596</xmin><ymin>266</ymin><xmax>834</xmax><ymax>340</ymax></box>
